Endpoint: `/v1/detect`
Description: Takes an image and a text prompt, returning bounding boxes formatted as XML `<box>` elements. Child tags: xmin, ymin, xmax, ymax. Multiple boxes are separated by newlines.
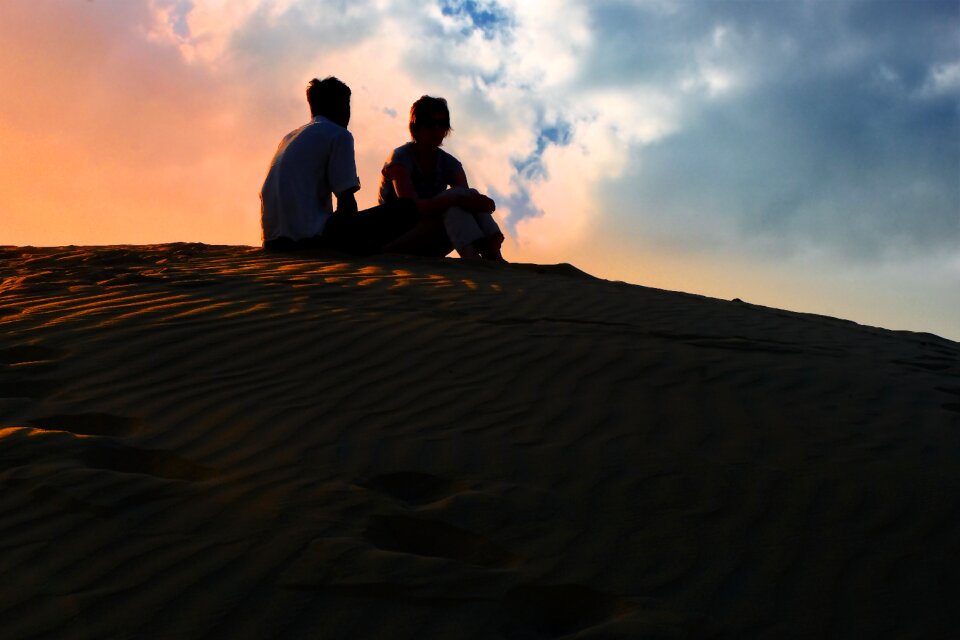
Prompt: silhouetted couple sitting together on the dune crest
<box><xmin>260</xmin><ymin>76</ymin><xmax>503</xmax><ymax>262</ymax></box>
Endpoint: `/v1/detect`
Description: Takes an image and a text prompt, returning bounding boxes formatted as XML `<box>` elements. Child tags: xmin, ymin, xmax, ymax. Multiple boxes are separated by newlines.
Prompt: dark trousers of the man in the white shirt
<box><xmin>263</xmin><ymin>199</ymin><xmax>419</xmax><ymax>256</ymax></box>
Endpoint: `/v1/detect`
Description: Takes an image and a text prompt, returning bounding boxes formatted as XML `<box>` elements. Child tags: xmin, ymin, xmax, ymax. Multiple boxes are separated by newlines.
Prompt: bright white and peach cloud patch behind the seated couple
<box><xmin>135</xmin><ymin>0</ymin><xmax>696</xmax><ymax>251</ymax></box>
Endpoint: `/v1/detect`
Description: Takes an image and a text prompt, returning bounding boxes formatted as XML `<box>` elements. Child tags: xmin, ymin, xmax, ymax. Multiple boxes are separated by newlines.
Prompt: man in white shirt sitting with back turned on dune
<box><xmin>260</xmin><ymin>76</ymin><xmax>428</xmax><ymax>255</ymax></box>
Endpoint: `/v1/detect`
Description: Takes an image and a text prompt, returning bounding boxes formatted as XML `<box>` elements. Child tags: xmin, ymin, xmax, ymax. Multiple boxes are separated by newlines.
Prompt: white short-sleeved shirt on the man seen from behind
<box><xmin>260</xmin><ymin>116</ymin><xmax>360</xmax><ymax>242</ymax></box>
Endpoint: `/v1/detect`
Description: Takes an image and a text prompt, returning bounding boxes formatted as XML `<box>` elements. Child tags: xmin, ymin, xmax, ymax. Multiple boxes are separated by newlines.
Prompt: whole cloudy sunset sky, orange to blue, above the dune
<box><xmin>0</xmin><ymin>0</ymin><xmax>960</xmax><ymax>340</ymax></box>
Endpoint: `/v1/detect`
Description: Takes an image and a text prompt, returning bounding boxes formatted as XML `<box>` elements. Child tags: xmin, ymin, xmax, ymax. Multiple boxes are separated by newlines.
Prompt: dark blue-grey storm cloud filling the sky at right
<box><xmin>582</xmin><ymin>1</ymin><xmax>960</xmax><ymax>259</ymax></box>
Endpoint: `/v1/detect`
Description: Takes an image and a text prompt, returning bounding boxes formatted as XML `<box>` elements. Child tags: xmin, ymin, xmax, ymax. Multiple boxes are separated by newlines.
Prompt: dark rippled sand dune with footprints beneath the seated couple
<box><xmin>0</xmin><ymin>244</ymin><xmax>960</xmax><ymax>640</ymax></box>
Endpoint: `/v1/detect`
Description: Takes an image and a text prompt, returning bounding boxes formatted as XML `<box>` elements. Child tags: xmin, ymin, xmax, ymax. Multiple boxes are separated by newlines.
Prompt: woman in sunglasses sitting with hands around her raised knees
<box><xmin>379</xmin><ymin>96</ymin><xmax>503</xmax><ymax>262</ymax></box>
